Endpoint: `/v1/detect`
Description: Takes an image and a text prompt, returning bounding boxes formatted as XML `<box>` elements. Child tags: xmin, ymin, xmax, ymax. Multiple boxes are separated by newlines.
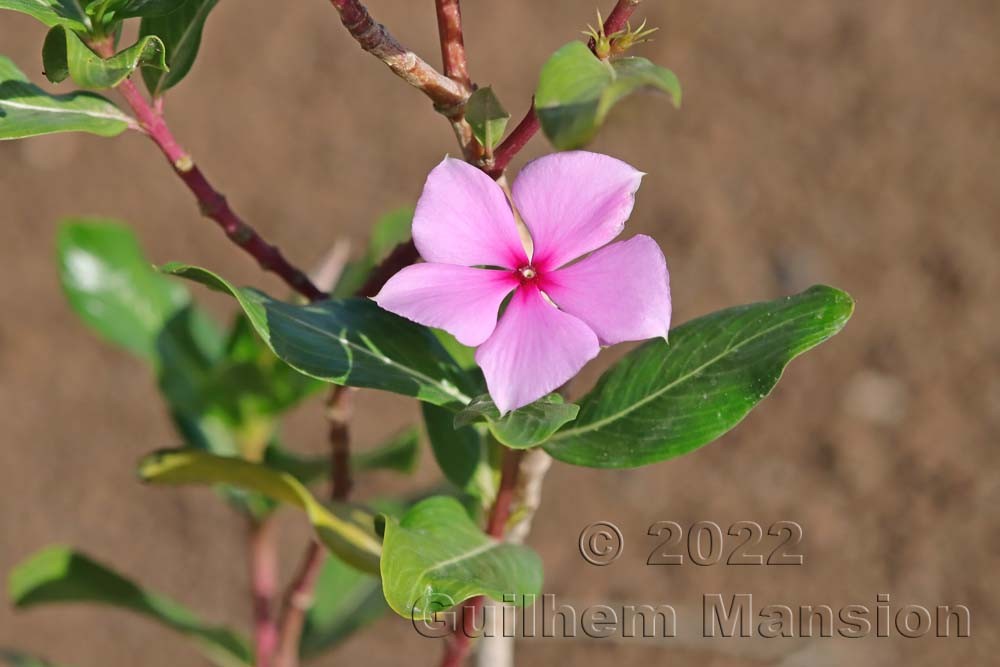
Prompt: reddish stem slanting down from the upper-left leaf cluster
<box><xmin>101</xmin><ymin>70</ymin><xmax>327</xmax><ymax>301</ymax></box>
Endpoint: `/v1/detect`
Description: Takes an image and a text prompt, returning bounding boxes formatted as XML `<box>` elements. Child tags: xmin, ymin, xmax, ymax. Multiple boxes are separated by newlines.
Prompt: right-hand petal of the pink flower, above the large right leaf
<box><xmin>540</xmin><ymin>235</ymin><xmax>670</xmax><ymax>345</ymax></box>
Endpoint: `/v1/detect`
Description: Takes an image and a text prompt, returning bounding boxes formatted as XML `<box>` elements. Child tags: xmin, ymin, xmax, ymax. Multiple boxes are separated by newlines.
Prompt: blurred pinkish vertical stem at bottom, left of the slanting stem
<box><xmin>248</xmin><ymin>518</ymin><xmax>278</xmax><ymax>667</ymax></box>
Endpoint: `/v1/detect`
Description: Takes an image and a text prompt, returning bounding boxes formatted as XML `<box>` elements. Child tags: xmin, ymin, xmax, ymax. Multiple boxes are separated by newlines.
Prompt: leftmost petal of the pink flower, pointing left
<box><xmin>374</xmin><ymin>264</ymin><xmax>518</xmax><ymax>347</ymax></box>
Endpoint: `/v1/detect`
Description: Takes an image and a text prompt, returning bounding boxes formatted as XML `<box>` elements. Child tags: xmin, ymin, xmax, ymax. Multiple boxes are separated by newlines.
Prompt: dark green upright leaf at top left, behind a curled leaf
<box><xmin>139</xmin><ymin>0</ymin><xmax>218</xmax><ymax>97</ymax></box>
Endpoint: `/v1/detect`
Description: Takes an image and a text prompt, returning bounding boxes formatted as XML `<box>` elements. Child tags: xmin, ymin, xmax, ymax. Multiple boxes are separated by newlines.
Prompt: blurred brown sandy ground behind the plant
<box><xmin>0</xmin><ymin>0</ymin><xmax>1000</xmax><ymax>667</ymax></box>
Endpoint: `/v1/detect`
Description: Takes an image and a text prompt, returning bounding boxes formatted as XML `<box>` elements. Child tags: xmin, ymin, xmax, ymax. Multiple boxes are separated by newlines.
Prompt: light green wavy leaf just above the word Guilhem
<box><xmin>381</xmin><ymin>496</ymin><xmax>542</xmax><ymax>620</ymax></box>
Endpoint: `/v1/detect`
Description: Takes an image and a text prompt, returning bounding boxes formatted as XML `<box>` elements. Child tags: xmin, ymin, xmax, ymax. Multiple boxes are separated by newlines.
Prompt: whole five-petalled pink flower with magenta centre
<box><xmin>375</xmin><ymin>151</ymin><xmax>670</xmax><ymax>414</ymax></box>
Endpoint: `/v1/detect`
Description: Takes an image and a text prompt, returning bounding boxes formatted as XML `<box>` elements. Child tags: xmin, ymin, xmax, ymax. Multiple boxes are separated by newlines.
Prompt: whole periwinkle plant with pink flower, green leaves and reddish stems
<box><xmin>0</xmin><ymin>0</ymin><xmax>853</xmax><ymax>667</ymax></box>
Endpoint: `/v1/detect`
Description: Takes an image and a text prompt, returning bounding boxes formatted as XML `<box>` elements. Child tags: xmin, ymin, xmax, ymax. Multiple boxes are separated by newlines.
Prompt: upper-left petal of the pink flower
<box><xmin>413</xmin><ymin>157</ymin><xmax>527</xmax><ymax>269</ymax></box>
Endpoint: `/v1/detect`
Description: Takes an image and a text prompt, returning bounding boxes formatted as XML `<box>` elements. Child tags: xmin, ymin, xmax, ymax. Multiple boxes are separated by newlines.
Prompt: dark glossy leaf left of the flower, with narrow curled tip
<box><xmin>162</xmin><ymin>264</ymin><xmax>470</xmax><ymax>405</ymax></box>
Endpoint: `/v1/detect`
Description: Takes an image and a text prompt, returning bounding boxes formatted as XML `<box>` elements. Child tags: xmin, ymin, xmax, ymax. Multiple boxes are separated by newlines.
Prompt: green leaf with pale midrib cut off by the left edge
<box><xmin>0</xmin><ymin>56</ymin><xmax>134</xmax><ymax>140</ymax></box>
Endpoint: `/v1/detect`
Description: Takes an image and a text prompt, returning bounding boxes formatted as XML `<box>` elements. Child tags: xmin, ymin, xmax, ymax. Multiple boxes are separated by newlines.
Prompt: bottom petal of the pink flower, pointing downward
<box><xmin>476</xmin><ymin>286</ymin><xmax>601</xmax><ymax>414</ymax></box>
